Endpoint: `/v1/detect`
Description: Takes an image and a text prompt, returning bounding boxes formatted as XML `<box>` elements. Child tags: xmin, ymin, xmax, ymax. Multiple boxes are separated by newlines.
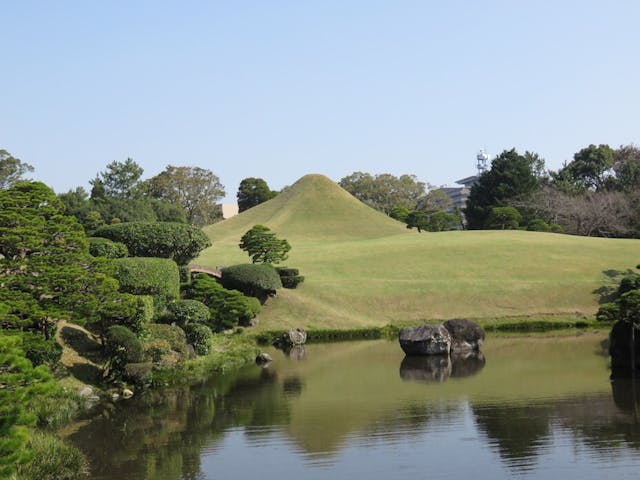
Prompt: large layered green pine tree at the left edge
<box><xmin>0</xmin><ymin>182</ymin><xmax>114</xmax><ymax>337</ymax></box>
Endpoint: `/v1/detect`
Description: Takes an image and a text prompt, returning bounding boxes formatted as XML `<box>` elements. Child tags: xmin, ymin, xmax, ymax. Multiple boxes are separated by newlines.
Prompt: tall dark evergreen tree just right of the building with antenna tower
<box><xmin>464</xmin><ymin>148</ymin><xmax>544</xmax><ymax>229</ymax></box>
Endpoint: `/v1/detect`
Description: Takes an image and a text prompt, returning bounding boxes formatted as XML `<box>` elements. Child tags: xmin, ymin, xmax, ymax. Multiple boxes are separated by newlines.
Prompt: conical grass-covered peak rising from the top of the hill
<box><xmin>205</xmin><ymin>174</ymin><xmax>406</xmax><ymax>244</ymax></box>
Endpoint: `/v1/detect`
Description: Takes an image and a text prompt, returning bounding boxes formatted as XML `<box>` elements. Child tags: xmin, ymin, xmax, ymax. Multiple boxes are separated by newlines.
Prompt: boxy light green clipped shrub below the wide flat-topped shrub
<box><xmin>114</xmin><ymin>257</ymin><xmax>180</xmax><ymax>311</ymax></box>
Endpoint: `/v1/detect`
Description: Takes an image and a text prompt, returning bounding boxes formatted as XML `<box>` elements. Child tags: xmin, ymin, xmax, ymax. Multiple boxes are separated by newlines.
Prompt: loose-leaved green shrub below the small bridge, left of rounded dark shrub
<box><xmin>185</xmin><ymin>273</ymin><xmax>260</xmax><ymax>331</ymax></box>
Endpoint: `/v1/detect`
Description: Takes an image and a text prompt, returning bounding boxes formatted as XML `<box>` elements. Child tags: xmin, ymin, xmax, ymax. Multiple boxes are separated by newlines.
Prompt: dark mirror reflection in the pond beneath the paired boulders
<box><xmin>400</xmin><ymin>352</ymin><xmax>486</xmax><ymax>383</ymax></box>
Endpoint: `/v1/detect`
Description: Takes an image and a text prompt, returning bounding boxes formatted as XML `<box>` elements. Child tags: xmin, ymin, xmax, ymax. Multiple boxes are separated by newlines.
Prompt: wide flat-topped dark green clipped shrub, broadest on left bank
<box><xmin>94</xmin><ymin>222</ymin><xmax>211</xmax><ymax>265</ymax></box>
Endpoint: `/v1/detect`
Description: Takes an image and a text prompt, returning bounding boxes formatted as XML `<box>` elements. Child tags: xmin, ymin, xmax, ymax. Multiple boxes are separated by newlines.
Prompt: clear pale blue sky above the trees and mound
<box><xmin>0</xmin><ymin>0</ymin><xmax>640</xmax><ymax>201</ymax></box>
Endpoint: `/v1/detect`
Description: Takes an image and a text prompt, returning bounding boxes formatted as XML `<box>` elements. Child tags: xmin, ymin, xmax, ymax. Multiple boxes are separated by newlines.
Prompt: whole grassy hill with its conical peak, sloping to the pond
<box><xmin>197</xmin><ymin>175</ymin><xmax>640</xmax><ymax>329</ymax></box>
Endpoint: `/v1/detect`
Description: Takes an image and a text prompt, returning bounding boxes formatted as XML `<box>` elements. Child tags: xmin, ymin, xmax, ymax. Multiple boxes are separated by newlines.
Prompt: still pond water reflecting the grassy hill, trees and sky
<box><xmin>68</xmin><ymin>333</ymin><xmax>640</xmax><ymax>480</ymax></box>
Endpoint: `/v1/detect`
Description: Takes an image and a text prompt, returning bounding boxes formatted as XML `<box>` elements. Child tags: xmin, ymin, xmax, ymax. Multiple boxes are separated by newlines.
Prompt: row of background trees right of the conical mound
<box><xmin>339</xmin><ymin>145</ymin><xmax>640</xmax><ymax>238</ymax></box>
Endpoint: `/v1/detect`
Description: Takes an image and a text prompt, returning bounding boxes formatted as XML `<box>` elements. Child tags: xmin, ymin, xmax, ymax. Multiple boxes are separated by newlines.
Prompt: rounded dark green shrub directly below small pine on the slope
<box><xmin>221</xmin><ymin>263</ymin><xmax>282</xmax><ymax>304</ymax></box>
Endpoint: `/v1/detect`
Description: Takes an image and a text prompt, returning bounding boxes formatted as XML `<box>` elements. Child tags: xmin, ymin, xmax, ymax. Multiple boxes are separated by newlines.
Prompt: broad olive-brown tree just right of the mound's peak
<box><xmin>339</xmin><ymin>172</ymin><xmax>426</xmax><ymax>215</ymax></box>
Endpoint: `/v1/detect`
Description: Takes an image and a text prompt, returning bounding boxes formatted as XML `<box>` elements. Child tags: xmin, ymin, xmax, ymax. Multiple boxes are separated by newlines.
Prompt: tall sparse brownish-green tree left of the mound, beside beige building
<box><xmin>145</xmin><ymin>165</ymin><xmax>225</xmax><ymax>226</ymax></box>
